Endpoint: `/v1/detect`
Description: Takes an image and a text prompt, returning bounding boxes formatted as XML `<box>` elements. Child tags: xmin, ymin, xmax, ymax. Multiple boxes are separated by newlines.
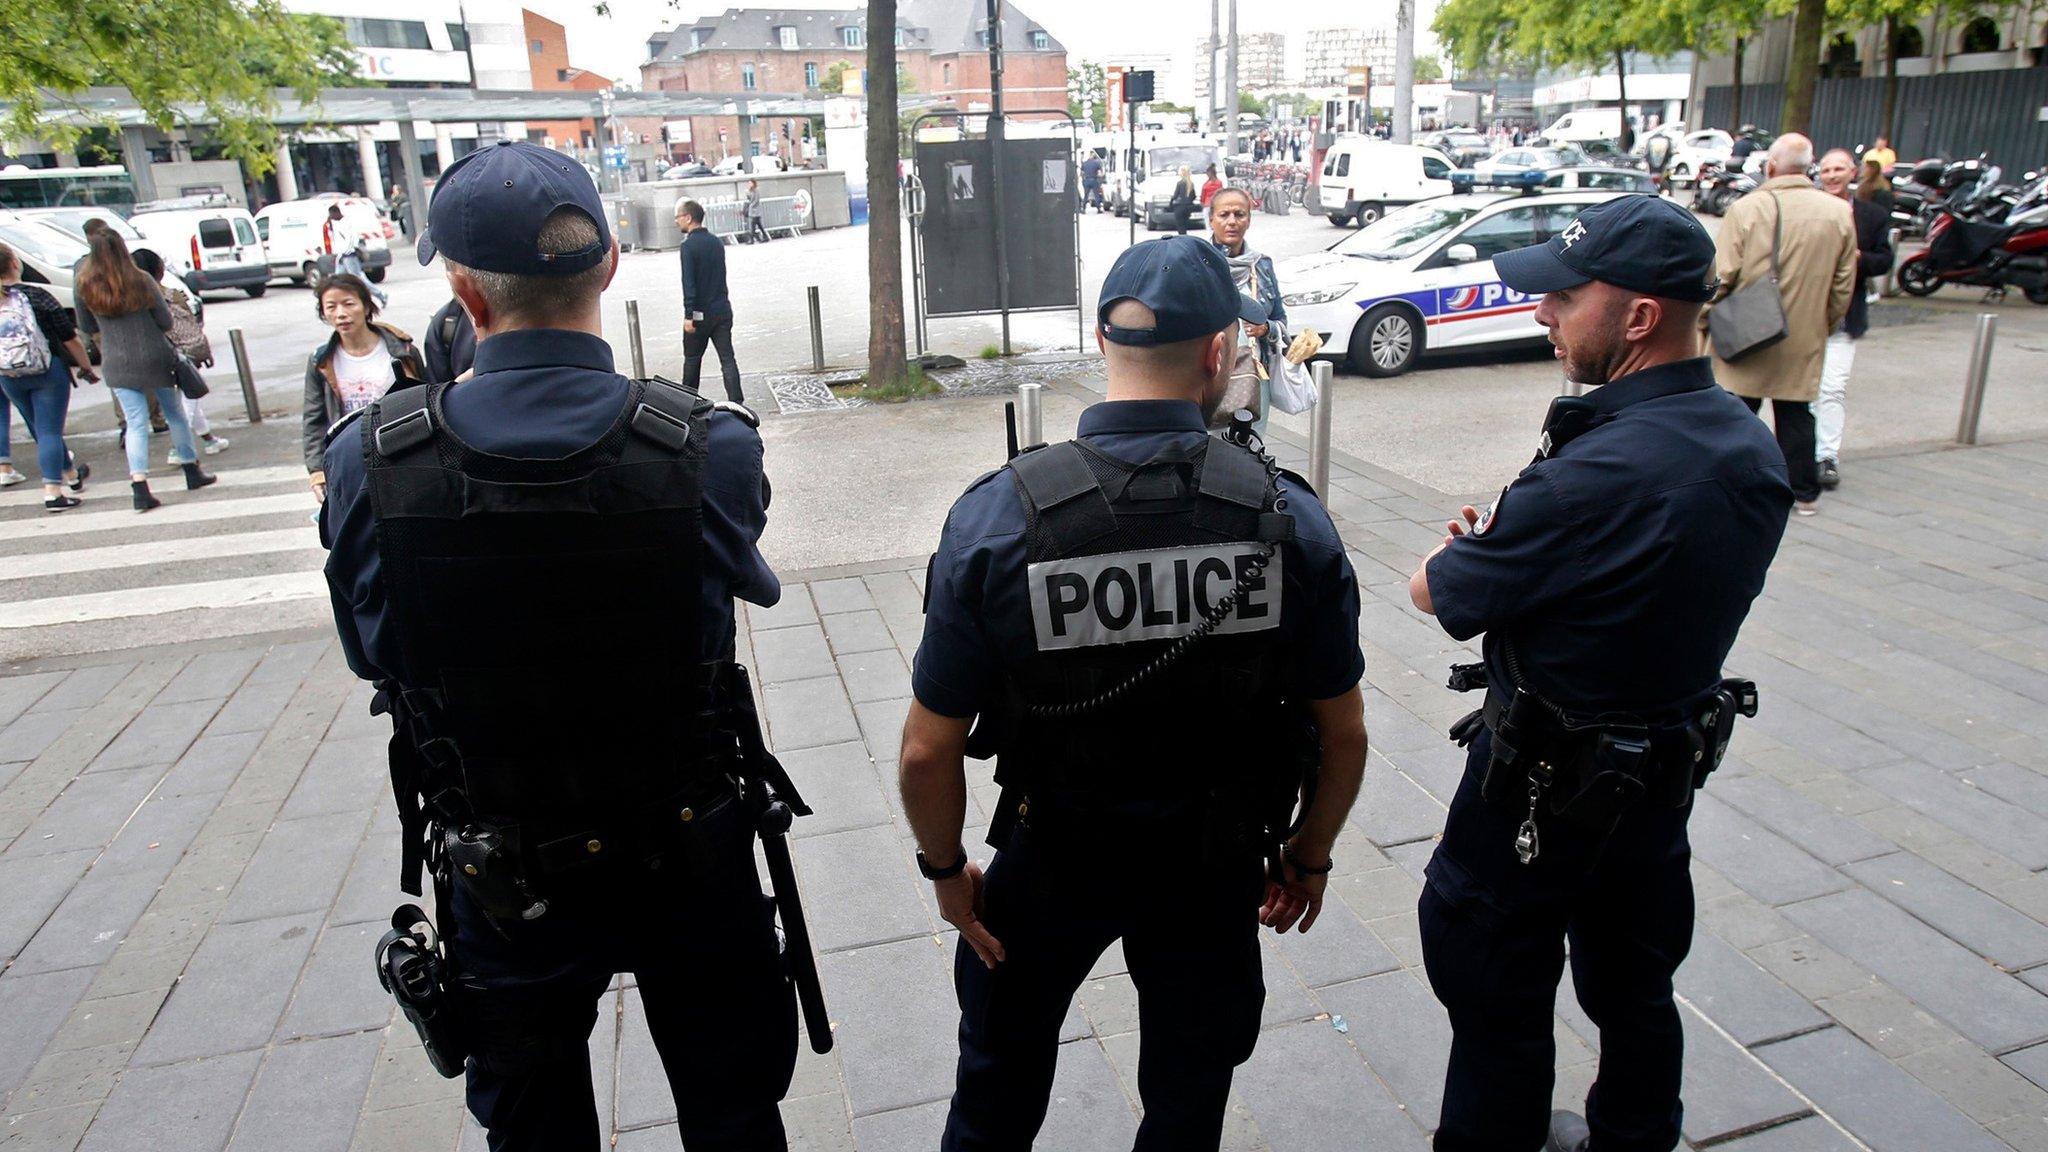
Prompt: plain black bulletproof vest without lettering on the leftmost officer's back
<box><xmin>362</xmin><ymin>381</ymin><xmax>711</xmax><ymax>851</ymax></box>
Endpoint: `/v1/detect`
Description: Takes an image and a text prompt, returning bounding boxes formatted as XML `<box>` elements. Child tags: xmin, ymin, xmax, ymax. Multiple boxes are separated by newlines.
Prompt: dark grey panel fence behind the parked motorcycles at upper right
<box><xmin>1706</xmin><ymin>68</ymin><xmax>2048</xmax><ymax>176</ymax></box>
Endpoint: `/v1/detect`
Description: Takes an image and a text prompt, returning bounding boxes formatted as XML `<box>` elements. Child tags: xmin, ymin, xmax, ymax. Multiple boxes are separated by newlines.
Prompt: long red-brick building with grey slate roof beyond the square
<box><xmin>631</xmin><ymin>0</ymin><xmax>1067</xmax><ymax>164</ymax></box>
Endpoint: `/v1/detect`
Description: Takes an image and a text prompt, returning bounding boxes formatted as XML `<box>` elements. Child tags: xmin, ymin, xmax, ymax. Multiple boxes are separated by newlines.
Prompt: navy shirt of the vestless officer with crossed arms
<box><xmin>1430</xmin><ymin>357</ymin><xmax>1792</xmax><ymax>711</ymax></box>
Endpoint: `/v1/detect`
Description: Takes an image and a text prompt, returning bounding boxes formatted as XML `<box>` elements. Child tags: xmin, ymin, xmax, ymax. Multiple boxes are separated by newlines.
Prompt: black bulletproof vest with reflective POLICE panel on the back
<box><xmin>997</xmin><ymin>439</ymin><xmax>1292</xmax><ymax>818</ymax></box>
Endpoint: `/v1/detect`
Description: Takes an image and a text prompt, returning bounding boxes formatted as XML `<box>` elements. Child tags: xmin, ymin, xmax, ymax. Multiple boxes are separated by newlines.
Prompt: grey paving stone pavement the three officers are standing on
<box><xmin>0</xmin><ymin>426</ymin><xmax>2048</xmax><ymax>1152</ymax></box>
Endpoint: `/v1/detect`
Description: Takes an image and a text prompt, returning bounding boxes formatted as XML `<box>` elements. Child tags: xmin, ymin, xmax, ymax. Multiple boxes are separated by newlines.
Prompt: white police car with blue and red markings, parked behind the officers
<box><xmin>1276</xmin><ymin>172</ymin><xmax>1632</xmax><ymax>377</ymax></box>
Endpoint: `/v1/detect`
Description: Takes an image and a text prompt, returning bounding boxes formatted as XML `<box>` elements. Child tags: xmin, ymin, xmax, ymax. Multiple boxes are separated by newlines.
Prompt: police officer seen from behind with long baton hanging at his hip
<box><xmin>322</xmin><ymin>141</ymin><xmax>797</xmax><ymax>1152</ymax></box>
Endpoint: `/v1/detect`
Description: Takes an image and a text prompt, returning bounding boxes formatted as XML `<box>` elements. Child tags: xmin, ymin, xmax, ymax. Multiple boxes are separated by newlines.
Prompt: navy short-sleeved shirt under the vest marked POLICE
<box><xmin>911</xmin><ymin>400</ymin><xmax>1359</xmax><ymax>717</ymax></box>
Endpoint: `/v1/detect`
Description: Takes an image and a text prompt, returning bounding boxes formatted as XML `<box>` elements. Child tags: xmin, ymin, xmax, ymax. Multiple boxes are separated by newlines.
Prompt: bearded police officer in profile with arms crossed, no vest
<box><xmin>1409</xmin><ymin>195</ymin><xmax>1792</xmax><ymax>1152</ymax></box>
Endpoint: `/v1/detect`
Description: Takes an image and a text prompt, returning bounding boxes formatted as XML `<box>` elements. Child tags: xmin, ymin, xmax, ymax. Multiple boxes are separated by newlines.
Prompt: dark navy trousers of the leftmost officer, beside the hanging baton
<box><xmin>453</xmin><ymin>806</ymin><xmax>797</xmax><ymax>1152</ymax></box>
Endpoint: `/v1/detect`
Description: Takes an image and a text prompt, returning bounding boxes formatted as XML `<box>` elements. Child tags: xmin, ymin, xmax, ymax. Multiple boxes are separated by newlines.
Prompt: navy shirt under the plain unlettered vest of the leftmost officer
<box><xmin>319</xmin><ymin>330</ymin><xmax>782</xmax><ymax>681</ymax></box>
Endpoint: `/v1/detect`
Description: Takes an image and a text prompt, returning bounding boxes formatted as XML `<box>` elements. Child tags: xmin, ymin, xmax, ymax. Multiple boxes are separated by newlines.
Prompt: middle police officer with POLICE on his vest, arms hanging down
<box><xmin>901</xmin><ymin>238</ymin><xmax>1366</xmax><ymax>1152</ymax></box>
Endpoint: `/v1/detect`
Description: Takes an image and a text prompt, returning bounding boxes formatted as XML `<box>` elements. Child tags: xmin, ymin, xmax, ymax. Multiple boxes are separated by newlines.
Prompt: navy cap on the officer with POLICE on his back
<box><xmin>1096</xmin><ymin>236</ymin><xmax>1270</xmax><ymax>346</ymax></box>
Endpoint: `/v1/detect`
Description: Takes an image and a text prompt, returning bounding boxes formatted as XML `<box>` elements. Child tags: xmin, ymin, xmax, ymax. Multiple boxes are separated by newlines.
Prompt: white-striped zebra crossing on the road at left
<box><xmin>0</xmin><ymin>457</ymin><xmax>330</xmax><ymax>660</ymax></box>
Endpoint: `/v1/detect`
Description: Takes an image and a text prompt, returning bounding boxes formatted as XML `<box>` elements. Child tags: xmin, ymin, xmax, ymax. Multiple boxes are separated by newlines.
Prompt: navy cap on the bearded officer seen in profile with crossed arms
<box><xmin>1493</xmin><ymin>195</ymin><xmax>1716</xmax><ymax>303</ymax></box>
